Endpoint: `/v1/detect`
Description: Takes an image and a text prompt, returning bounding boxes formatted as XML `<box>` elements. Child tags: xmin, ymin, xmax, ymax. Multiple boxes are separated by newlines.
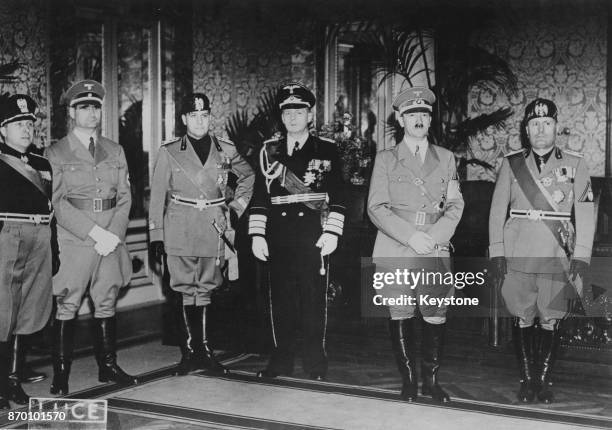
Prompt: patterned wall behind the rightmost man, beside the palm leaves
<box><xmin>469</xmin><ymin>1</ymin><xmax>607</xmax><ymax>180</ymax></box>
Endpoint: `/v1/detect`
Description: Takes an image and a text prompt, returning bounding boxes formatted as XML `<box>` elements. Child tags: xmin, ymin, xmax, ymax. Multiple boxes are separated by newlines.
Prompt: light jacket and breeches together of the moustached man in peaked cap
<box><xmin>368</xmin><ymin>141</ymin><xmax>464</xmax><ymax>319</ymax></box>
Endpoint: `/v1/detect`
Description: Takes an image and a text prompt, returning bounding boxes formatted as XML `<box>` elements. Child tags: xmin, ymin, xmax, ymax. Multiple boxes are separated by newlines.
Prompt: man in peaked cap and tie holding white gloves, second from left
<box><xmin>47</xmin><ymin>80</ymin><xmax>136</xmax><ymax>395</ymax></box>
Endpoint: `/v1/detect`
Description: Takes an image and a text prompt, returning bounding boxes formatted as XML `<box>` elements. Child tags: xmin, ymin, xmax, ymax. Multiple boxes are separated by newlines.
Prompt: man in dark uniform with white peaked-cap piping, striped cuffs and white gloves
<box><xmin>249</xmin><ymin>83</ymin><xmax>345</xmax><ymax>380</ymax></box>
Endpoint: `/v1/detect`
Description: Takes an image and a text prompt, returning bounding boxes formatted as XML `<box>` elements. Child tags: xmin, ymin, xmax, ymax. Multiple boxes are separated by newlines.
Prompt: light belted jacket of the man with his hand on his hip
<box><xmin>149</xmin><ymin>136</ymin><xmax>255</xmax><ymax>257</ymax></box>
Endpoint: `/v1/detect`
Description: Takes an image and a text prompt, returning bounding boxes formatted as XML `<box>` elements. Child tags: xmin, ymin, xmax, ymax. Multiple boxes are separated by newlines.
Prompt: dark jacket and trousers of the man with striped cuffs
<box><xmin>249</xmin><ymin>136</ymin><xmax>345</xmax><ymax>375</ymax></box>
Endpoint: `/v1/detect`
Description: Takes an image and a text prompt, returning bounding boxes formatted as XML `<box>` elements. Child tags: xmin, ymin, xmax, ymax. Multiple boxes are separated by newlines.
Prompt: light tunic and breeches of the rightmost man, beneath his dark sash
<box><xmin>489</xmin><ymin>148</ymin><xmax>595</xmax><ymax>321</ymax></box>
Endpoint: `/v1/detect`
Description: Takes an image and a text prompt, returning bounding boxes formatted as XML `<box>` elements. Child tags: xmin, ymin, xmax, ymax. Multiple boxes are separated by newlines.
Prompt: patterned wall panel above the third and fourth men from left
<box><xmin>193</xmin><ymin>2</ymin><xmax>314</xmax><ymax>135</ymax></box>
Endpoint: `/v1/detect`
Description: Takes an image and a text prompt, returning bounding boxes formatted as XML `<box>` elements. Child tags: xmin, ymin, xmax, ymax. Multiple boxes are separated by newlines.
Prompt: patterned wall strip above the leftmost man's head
<box><xmin>0</xmin><ymin>0</ymin><xmax>49</xmax><ymax>145</ymax></box>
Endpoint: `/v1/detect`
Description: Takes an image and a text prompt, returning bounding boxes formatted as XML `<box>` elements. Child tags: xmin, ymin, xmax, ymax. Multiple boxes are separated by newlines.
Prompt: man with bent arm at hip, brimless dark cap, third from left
<box><xmin>149</xmin><ymin>93</ymin><xmax>255</xmax><ymax>375</ymax></box>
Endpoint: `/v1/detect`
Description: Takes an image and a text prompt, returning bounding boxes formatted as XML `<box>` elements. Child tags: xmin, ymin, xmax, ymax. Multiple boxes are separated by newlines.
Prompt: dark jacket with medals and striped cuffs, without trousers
<box><xmin>249</xmin><ymin>135</ymin><xmax>346</xmax><ymax>240</ymax></box>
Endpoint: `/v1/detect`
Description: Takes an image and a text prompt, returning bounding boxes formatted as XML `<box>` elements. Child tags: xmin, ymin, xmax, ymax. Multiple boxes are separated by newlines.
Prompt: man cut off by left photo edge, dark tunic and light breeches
<box><xmin>0</xmin><ymin>94</ymin><xmax>59</xmax><ymax>409</ymax></box>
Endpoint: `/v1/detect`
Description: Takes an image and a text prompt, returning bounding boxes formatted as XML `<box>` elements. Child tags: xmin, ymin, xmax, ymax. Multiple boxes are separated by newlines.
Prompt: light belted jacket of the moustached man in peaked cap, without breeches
<box><xmin>368</xmin><ymin>141</ymin><xmax>464</xmax><ymax>257</ymax></box>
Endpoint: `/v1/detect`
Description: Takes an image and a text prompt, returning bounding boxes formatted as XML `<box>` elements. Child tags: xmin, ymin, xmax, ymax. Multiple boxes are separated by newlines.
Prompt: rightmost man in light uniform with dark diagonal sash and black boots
<box><xmin>489</xmin><ymin>99</ymin><xmax>595</xmax><ymax>403</ymax></box>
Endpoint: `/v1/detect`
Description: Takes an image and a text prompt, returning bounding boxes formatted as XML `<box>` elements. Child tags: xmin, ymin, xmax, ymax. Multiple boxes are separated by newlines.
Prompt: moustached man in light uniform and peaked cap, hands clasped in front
<box><xmin>368</xmin><ymin>87</ymin><xmax>464</xmax><ymax>402</ymax></box>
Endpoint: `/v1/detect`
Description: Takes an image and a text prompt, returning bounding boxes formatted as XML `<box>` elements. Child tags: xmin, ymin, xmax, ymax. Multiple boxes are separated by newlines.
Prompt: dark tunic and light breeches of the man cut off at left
<box><xmin>0</xmin><ymin>144</ymin><xmax>57</xmax><ymax>341</ymax></box>
